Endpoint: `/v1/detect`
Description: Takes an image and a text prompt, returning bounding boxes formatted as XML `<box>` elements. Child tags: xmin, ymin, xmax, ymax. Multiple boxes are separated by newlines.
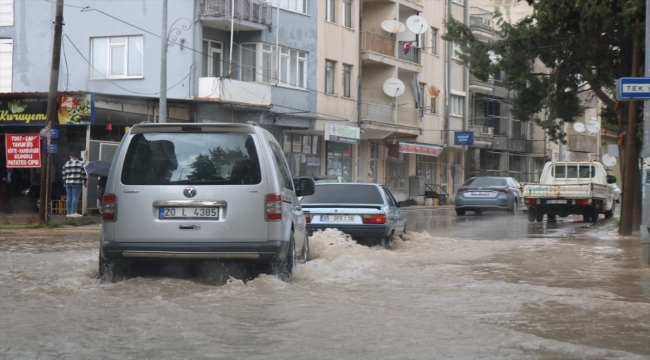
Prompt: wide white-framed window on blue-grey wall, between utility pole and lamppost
<box><xmin>90</xmin><ymin>36</ymin><xmax>144</xmax><ymax>79</ymax></box>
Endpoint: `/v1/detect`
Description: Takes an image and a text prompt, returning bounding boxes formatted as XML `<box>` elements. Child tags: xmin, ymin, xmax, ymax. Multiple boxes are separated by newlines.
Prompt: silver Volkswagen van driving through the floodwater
<box><xmin>99</xmin><ymin>123</ymin><xmax>314</xmax><ymax>282</ymax></box>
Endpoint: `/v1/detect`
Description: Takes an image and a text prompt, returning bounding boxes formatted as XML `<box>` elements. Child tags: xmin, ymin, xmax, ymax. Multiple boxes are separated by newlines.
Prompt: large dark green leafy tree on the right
<box><xmin>442</xmin><ymin>0</ymin><xmax>645</xmax><ymax>234</ymax></box>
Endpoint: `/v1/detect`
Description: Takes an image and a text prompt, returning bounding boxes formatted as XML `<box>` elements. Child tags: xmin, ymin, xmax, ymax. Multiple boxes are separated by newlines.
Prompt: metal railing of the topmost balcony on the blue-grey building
<box><xmin>201</xmin><ymin>0</ymin><xmax>272</xmax><ymax>26</ymax></box>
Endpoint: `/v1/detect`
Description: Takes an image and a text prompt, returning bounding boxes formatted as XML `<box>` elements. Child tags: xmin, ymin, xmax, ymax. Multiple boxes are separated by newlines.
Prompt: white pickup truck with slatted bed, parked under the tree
<box><xmin>521</xmin><ymin>161</ymin><xmax>616</xmax><ymax>222</ymax></box>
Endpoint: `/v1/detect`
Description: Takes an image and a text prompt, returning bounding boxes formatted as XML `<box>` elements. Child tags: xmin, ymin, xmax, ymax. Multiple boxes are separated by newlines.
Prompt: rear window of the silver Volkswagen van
<box><xmin>121</xmin><ymin>133</ymin><xmax>262</xmax><ymax>185</ymax></box>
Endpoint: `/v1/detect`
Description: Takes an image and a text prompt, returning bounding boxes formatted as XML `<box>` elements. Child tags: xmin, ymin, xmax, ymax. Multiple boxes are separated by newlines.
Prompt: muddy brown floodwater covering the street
<box><xmin>0</xmin><ymin>210</ymin><xmax>650</xmax><ymax>359</ymax></box>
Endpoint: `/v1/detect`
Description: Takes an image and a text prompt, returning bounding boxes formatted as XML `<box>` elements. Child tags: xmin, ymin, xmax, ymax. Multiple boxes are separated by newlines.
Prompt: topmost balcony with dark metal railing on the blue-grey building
<box><xmin>200</xmin><ymin>0</ymin><xmax>273</xmax><ymax>31</ymax></box>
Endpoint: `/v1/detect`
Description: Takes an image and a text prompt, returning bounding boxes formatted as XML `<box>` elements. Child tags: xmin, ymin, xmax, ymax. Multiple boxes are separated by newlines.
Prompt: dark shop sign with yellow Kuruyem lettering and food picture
<box><xmin>0</xmin><ymin>93</ymin><xmax>95</xmax><ymax>126</ymax></box>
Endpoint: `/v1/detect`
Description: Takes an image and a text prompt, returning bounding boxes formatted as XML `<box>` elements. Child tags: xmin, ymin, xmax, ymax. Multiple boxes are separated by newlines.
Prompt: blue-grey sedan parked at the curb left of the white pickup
<box><xmin>455</xmin><ymin>176</ymin><xmax>521</xmax><ymax>215</ymax></box>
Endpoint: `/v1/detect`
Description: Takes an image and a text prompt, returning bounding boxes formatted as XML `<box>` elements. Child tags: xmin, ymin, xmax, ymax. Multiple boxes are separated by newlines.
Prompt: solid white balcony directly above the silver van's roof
<box><xmin>198</xmin><ymin>77</ymin><xmax>271</xmax><ymax>106</ymax></box>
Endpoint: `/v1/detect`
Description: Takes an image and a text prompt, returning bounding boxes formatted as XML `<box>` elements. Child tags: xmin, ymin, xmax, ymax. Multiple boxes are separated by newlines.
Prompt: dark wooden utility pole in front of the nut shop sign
<box><xmin>38</xmin><ymin>0</ymin><xmax>63</xmax><ymax>225</ymax></box>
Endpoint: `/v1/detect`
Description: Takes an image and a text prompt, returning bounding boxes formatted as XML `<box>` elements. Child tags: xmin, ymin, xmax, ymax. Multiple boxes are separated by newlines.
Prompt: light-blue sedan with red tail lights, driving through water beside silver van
<box><xmin>301</xmin><ymin>183</ymin><xmax>406</xmax><ymax>249</ymax></box>
